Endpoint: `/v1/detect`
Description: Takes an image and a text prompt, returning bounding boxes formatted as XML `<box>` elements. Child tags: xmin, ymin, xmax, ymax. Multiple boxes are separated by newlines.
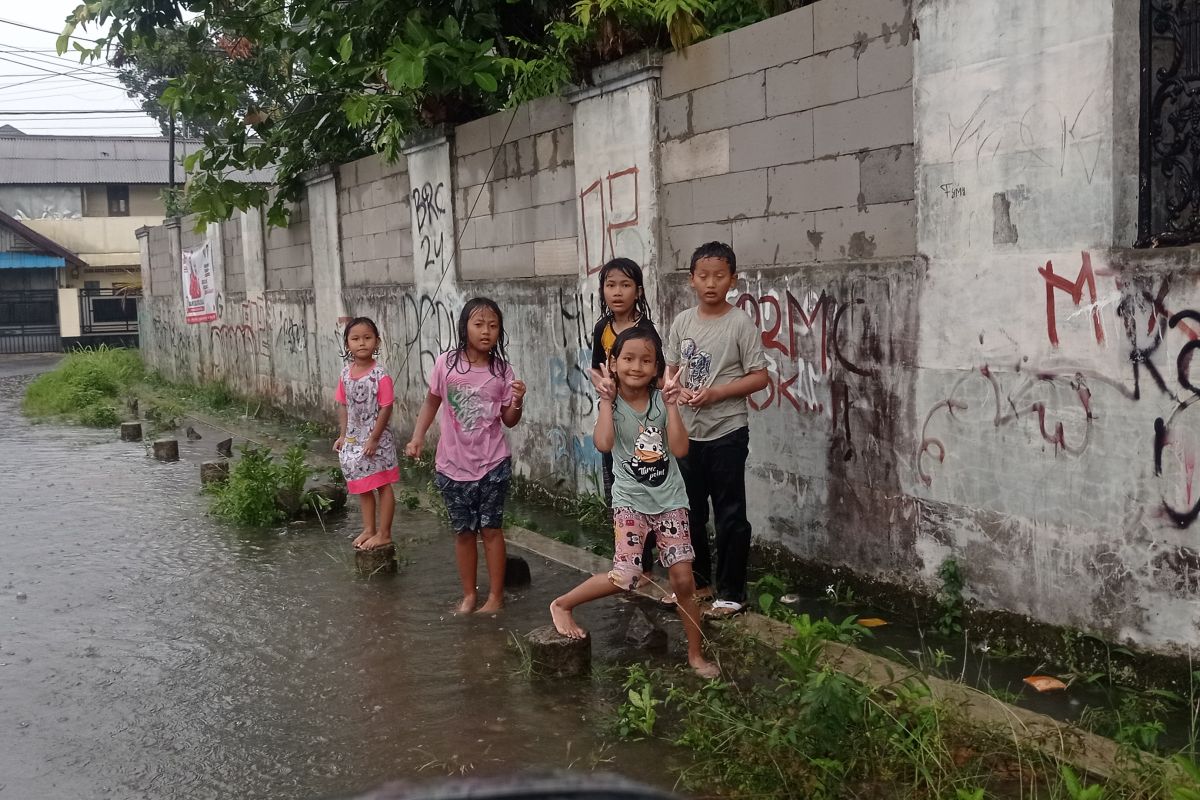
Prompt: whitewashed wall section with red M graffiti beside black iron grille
<box><xmin>905</xmin><ymin>0</ymin><xmax>1200</xmax><ymax>649</ymax></box>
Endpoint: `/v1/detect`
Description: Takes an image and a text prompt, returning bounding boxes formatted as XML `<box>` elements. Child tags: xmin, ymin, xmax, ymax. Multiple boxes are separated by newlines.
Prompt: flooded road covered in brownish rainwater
<box><xmin>0</xmin><ymin>359</ymin><xmax>682</xmax><ymax>800</ymax></box>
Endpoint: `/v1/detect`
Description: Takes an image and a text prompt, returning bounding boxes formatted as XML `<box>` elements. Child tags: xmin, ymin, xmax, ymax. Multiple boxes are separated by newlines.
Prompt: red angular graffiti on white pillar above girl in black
<box><xmin>580</xmin><ymin>167</ymin><xmax>646</xmax><ymax>275</ymax></box>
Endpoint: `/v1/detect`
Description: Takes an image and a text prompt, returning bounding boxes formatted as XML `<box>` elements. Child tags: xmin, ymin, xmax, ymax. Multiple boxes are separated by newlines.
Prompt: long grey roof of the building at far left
<box><xmin>0</xmin><ymin>126</ymin><xmax>271</xmax><ymax>186</ymax></box>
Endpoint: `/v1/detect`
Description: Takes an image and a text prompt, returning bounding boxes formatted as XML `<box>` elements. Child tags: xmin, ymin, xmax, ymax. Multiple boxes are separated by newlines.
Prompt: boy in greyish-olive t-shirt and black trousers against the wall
<box><xmin>666</xmin><ymin>242</ymin><xmax>768</xmax><ymax>618</ymax></box>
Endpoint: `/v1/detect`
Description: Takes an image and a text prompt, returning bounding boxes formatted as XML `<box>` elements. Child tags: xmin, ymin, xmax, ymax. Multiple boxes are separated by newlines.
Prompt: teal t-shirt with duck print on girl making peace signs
<box><xmin>612</xmin><ymin>391</ymin><xmax>688</xmax><ymax>513</ymax></box>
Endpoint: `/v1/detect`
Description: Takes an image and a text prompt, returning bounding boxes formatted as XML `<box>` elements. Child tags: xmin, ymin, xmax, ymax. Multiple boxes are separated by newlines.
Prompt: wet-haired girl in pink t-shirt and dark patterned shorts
<box><xmin>404</xmin><ymin>297</ymin><xmax>526</xmax><ymax>614</ymax></box>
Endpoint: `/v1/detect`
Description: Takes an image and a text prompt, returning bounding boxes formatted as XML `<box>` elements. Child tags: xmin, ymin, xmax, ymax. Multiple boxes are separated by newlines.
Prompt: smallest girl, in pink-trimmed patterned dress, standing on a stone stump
<box><xmin>334</xmin><ymin>317</ymin><xmax>400</xmax><ymax>549</ymax></box>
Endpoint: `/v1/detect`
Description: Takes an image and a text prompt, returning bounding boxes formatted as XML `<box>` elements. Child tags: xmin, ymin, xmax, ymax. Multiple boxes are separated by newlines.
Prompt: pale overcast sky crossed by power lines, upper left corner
<box><xmin>0</xmin><ymin>0</ymin><xmax>162</xmax><ymax>136</ymax></box>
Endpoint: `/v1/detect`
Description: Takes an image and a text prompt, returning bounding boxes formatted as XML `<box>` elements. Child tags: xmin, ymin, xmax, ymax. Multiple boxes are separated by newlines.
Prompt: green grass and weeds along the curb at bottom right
<box><xmin>595</xmin><ymin>577</ymin><xmax>1200</xmax><ymax>800</ymax></box>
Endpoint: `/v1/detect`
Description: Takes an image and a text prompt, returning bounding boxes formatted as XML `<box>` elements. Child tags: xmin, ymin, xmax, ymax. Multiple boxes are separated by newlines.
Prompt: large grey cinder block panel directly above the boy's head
<box><xmin>659</xmin><ymin>0</ymin><xmax>917</xmax><ymax>269</ymax></box>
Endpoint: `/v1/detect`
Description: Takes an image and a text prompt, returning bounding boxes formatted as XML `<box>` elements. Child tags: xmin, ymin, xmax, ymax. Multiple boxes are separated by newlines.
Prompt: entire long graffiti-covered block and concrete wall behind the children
<box><xmin>131</xmin><ymin>0</ymin><xmax>1200</xmax><ymax>651</ymax></box>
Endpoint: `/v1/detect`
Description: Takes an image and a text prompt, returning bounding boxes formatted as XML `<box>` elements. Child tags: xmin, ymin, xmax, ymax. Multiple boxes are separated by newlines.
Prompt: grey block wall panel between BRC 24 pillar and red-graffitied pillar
<box><xmin>454</xmin><ymin>97</ymin><xmax>578</xmax><ymax>281</ymax></box>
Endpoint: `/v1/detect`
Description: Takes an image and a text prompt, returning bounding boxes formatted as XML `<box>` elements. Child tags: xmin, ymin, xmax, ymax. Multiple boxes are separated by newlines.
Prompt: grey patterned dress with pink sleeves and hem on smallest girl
<box><xmin>334</xmin><ymin>363</ymin><xmax>400</xmax><ymax>494</ymax></box>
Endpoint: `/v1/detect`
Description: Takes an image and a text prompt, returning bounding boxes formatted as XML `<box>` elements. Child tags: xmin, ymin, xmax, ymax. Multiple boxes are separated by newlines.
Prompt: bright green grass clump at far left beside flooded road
<box><xmin>23</xmin><ymin>345</ymin><xmax>145</xmax><ymax>427</ymax></box>
